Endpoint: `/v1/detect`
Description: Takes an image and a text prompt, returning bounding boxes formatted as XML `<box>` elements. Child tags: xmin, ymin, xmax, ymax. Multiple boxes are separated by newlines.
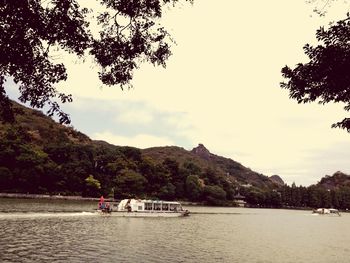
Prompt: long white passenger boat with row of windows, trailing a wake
<box><xmin>100</xmin><ymin>199</ymin><xmax>190</xmax><ymax>217</ymax></box>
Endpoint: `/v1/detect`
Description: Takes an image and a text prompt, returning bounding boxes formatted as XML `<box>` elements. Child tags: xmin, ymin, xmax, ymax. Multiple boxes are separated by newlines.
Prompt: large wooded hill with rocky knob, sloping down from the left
<box><xmin>0</xmin><ymin>102</ymin><xmax>278</xmax><ymax>202</ymax></box>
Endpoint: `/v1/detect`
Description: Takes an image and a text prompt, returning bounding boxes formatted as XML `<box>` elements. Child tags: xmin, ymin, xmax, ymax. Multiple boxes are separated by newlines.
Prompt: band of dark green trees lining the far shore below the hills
<box><xmin>0</xmin><ymin>125</ymin><xmax>350</xmax><ymax>209</ymax></box>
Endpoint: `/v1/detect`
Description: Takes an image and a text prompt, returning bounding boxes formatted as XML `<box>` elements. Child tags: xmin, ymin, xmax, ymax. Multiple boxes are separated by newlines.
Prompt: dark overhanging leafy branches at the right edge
<box><xmin>281</xmin><ymin>14</ymin><xmax>350</xmax><ymax>131</ymax></box>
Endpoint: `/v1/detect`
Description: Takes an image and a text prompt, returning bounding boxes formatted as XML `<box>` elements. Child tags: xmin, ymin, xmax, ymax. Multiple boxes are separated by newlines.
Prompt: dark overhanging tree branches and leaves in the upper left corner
<box><xmin>0</xmin><ymin>0</ymin><xmax>191</xmax><ymax>124</ymax></box>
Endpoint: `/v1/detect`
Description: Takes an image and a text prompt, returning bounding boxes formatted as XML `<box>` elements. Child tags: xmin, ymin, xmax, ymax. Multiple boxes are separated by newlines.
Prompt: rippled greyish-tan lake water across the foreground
<box><xmin>0</xmin><ymin>198</ymin><xmax>350</xmax><ymax>263</ymax></box>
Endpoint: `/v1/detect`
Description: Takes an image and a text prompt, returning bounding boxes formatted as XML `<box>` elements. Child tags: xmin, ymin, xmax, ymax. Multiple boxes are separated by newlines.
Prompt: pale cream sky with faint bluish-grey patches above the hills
<box><xmin>7</xmin><ymin>0</ymin><xmax>350</xmax><ymax>186</ymax></box>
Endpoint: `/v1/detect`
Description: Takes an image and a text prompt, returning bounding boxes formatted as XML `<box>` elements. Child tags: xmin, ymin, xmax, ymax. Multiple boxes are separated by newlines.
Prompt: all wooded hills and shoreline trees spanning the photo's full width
<box><xmin>0</xmin><ymin>100</ymin><xmax>350</xmax><ymax>209</ymax></box>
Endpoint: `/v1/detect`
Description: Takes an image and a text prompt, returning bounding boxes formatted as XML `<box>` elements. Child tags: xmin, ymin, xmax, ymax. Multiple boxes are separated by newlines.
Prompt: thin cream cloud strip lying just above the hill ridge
<box><xmin>92</xmin><ymin>131</ymin><xmax>175</xmax><ymax>149</ymax></box>
